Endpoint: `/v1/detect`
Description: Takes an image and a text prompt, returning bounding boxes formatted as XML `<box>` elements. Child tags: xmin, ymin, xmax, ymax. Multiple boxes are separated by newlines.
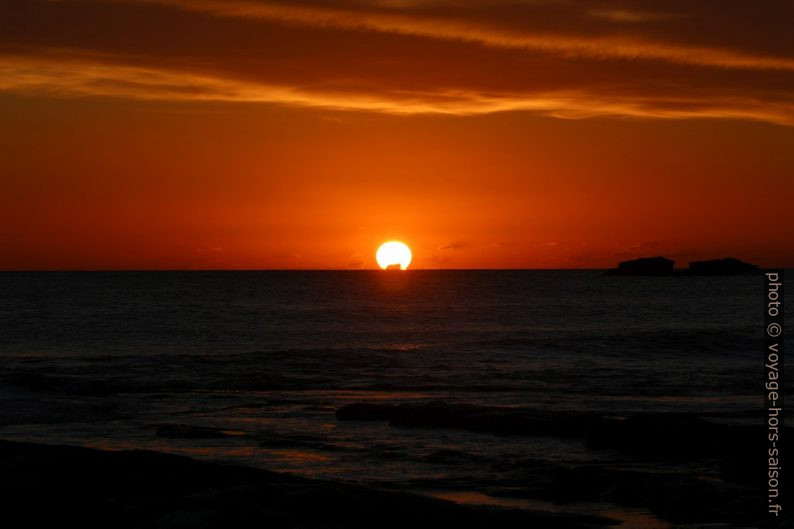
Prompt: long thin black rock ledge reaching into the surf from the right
<box><xmin>336</xmin><ymin>401</ymin><xmax>794</xmax><ymax>462</ymax></box>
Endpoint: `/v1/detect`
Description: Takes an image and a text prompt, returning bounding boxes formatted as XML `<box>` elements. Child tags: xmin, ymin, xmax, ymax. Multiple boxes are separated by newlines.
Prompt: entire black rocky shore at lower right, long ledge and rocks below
<box><xmin>336</xmin><ymin>401</ymin><xmax>780</xmax><ymax>527</ymax></box>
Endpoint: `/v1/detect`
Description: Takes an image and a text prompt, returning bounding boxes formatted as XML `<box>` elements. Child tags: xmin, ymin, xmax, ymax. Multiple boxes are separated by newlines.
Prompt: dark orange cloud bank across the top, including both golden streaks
<box><xmin>0</xmin><ymin>0</ymin><xmax>794</xmax><ymax>126</ymax></box>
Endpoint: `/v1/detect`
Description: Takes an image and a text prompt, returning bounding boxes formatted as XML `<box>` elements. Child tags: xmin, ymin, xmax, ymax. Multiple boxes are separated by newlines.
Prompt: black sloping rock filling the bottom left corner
<box><xmin>0</xmin><ymin>441</ymin><xmax>611</xmax><ymax>529</ymax></box>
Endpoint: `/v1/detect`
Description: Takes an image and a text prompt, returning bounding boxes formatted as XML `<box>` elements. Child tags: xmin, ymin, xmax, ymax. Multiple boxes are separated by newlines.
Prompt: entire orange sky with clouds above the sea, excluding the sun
<box><xmin>0</xmin><ymin>0</ymin><xmax>794</xmax><ymax>269</ymax></box>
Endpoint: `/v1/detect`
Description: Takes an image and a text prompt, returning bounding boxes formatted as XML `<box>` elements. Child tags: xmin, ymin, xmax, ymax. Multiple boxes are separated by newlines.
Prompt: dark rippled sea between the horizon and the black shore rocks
<box><xmin>0</xmin><ymin>270</ymin><xmax>784</xmax><ymax>524</ymax></box>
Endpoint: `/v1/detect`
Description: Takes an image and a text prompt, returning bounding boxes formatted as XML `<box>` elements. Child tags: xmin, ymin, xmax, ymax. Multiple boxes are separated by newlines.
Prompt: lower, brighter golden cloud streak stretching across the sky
<box><xmin>0</xmin><ymin>56</ymin><xmax>794</xmax><ymax>125</ymax></box>
